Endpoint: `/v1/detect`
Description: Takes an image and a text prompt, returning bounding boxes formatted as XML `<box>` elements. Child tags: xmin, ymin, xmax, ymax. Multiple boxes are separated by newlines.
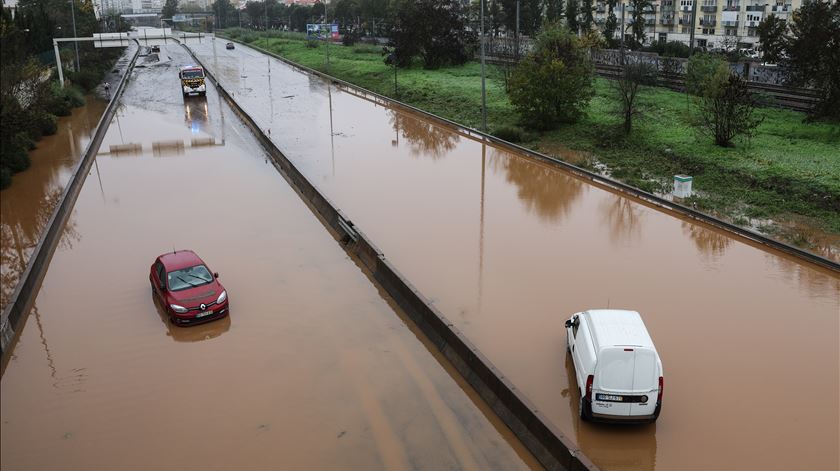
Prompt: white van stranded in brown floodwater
<box><xmin>566</xmin><ymin>309</ymin><xmax>664</xmax><ymax>422</ymax></box>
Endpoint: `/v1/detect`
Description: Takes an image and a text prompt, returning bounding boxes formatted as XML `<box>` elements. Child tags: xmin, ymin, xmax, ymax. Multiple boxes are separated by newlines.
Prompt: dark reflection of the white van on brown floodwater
<box><xmin>560</xmin><ymin>353</ymin><xmax>656</xmax><ymax>471</ymax></box>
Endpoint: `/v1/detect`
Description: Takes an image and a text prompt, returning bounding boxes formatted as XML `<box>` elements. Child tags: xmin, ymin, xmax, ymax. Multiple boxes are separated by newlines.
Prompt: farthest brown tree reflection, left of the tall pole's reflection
<box><xmin>389</xmin><ymin>110</ymin><xmax>459</xmax><ymax>160</ymax></box>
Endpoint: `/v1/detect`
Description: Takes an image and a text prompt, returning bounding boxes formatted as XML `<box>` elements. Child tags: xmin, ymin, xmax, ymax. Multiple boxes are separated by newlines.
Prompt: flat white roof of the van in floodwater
<box><xmin>583</xmin><ymin>309</ymin><xmax>656</xmax><ymax>350</ymax></box>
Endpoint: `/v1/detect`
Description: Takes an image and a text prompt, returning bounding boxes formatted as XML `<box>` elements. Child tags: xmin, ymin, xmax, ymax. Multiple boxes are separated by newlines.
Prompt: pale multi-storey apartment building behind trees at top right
<box><xmin>595</xmin><ymin>0</ymin><xmax>802</xmax><ymax>49</ymax></box>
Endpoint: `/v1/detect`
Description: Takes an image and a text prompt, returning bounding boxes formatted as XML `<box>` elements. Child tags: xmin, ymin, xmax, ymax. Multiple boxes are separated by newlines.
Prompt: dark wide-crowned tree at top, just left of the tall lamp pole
<box><xmin>389</xmin><ymin>0</ymin><xmax>477</xmax><ymax>69</ymax></box>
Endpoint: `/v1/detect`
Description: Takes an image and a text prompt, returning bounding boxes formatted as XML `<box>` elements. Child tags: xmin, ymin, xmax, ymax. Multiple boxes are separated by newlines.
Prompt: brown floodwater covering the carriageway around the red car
<box><xmin>0</xmin><ymin>46</ymin><xmax>535</xmax><ymax>470</ymax></box>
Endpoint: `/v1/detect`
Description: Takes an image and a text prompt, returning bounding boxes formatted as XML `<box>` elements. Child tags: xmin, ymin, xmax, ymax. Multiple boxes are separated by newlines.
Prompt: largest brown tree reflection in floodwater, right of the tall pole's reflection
<box><xmin>490</xmin><ymin>148</ymin><xmax>584</xmax><ymax>223</ymax></box>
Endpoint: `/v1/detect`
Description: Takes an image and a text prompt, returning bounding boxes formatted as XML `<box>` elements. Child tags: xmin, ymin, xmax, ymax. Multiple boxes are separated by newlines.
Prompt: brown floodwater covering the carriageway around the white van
<box><xmin>185</xmin><ymin>39</ymin><xmax>840</xmax><ymax>470</ymax></box>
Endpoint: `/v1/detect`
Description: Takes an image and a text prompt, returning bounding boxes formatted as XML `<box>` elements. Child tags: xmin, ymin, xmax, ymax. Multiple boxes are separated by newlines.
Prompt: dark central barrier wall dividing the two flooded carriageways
<box><xmin>185</xmin><ymin>42</ymin><xmax>598</xmax><ymax>471</ymax></box>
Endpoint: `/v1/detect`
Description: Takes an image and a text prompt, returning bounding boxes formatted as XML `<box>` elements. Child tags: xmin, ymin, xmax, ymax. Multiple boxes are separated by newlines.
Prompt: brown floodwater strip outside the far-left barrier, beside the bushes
<box><xmin>0</xmin><ymin>96</ymin><xmax>108</xmax><ymax>311</ymax></box>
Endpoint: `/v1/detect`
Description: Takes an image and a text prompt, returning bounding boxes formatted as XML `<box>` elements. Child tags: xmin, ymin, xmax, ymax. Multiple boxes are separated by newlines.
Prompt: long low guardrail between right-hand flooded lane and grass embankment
<box><xmin>219</xmin><ymin>35</ymin><xmax>840</xmax><ymax>273</ymax></box>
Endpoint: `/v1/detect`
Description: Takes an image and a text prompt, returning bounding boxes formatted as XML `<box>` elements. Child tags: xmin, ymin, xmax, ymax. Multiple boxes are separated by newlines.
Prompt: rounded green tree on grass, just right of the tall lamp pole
<box><xmin>508</xmin><ymin>23</ymin><xmax>595</xmax><ymax>130</ymax></box>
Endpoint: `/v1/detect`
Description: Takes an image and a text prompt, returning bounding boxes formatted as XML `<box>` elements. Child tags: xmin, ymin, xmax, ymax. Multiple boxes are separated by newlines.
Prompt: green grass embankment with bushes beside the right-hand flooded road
<box><xmin>221</xmin><ymin>30</ymin><xmax>840</xmax><ymax>244</ymax></box>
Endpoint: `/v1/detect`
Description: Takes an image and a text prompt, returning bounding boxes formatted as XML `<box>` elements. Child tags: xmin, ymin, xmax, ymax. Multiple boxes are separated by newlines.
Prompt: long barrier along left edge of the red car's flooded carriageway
<box><xmin>0</xmin><ymin>41</ymin><xmax>140</xmax><ymax>371</ymax></box>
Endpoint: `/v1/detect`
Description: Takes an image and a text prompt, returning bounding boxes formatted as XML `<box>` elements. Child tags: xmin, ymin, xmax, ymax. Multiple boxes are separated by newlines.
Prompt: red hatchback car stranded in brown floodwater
<box><xmin>149</xmin><ymin>250</ymin><xmax>228</xmax><ymax>325</ymax></box>
